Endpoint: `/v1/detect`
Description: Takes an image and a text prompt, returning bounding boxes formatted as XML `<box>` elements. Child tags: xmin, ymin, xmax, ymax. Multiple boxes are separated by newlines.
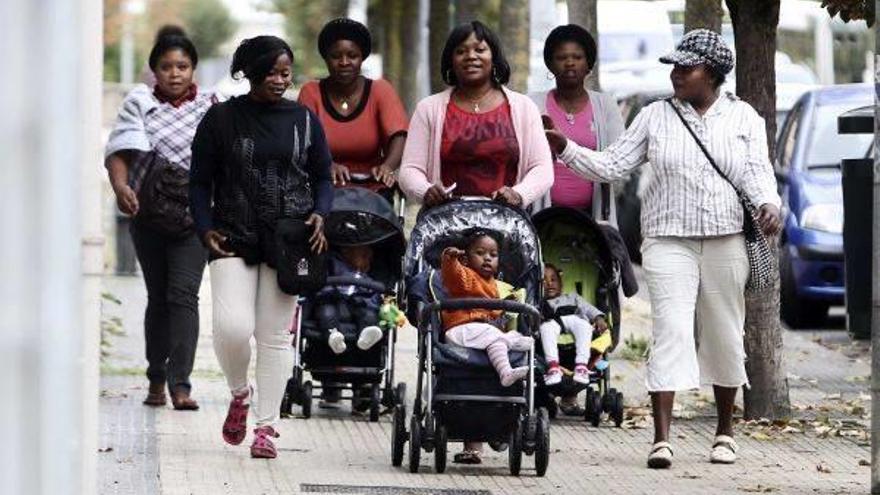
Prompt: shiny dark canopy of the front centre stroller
<box><xmin>404</xmin><ymin>200</ymin><xmax>543</xmax><ymax>304</ymax></box>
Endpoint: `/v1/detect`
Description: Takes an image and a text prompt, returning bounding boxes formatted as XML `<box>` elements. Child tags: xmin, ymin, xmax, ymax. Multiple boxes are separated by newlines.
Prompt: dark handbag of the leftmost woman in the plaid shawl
<box><xmin>135</xmin><ymin>153</ymin><xmax>194</xmax><ymax>239</ymax></box>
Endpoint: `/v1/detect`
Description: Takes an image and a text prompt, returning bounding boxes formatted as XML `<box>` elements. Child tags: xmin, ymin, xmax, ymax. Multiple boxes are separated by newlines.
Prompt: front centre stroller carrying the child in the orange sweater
<box><xmin>391</xmin><ymin>200</ymin><xmax>550</xmax><ymax>476</ymax></box>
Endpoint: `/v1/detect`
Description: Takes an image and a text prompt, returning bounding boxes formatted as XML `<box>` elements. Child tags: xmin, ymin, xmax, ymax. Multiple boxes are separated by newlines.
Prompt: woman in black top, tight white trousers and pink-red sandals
<box><xmin>190</xmin><ymin>36</ymin><xmax>333</xmax><ymax>458</ymax></box>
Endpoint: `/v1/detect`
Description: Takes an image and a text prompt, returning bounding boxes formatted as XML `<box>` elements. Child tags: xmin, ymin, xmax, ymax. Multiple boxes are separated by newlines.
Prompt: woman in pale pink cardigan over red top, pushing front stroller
<box><xmin>399</xmin><ymin>21</ymin><xmax>553</xmax><ymax>464</ymax></box>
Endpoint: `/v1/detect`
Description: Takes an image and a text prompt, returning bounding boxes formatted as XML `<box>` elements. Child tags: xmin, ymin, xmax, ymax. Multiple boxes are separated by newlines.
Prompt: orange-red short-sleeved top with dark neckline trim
<box><xmin>299</xmin><ymin>78</ymin><xmax>409</xmax><ymax>191</ymax></box>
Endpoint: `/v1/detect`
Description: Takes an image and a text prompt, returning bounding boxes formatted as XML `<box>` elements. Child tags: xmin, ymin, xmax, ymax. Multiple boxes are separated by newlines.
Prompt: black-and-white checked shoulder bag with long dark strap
<box><xmin>666</xmin><ymin>98</ymin><xmax>779</xmax><ymax>291</ymax></box>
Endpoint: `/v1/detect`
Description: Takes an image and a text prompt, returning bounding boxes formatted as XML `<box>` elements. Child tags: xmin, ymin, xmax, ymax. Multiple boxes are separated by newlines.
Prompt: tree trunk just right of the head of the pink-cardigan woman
<box><xmin>499</xmin><ymin>0</ymin><xmax>529</xmax><ymax>93</ymax></box>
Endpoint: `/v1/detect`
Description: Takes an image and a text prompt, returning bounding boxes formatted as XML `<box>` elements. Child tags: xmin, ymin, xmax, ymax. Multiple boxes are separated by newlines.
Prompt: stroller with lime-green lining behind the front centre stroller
<box><xmin>532</xmin><ymin>207</ymin><xmax>623</xmax><ymax>426</ymax></box>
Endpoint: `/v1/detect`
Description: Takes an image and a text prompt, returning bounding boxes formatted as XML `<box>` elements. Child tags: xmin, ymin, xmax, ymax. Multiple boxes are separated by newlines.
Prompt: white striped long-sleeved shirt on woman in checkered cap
<box><xmin>559</xmin><ymin>93</ymin><xmax>781</xmax><ymax>237</ymax></box>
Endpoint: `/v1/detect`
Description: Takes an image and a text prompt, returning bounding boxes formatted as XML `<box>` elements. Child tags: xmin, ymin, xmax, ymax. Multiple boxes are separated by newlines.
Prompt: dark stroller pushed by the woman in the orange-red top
<box><xmin>281</xmin><ymin>188</ymin><xmax>406</xmax><ymax>422</ymax></box>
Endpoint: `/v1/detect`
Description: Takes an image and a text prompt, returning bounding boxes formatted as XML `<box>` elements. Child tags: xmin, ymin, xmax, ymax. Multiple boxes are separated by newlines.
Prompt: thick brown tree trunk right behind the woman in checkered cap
<box><xmin>727</xmin><ymin>0</ymin><xmax>791</xmax><ymax>419</ymax></box>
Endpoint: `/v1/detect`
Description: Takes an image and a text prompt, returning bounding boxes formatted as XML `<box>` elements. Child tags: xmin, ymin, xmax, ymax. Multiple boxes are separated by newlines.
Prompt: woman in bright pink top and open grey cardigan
<box><xmin>530</xmin><ymin>24</ymin><xmax>631</xmax><ymax>417</ymax></box>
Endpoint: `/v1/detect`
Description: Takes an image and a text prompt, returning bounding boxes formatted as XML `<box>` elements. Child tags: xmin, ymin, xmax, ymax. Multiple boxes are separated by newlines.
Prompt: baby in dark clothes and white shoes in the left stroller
<box><xmin>315</xmin><ymin>245</ymin><xmax>382</xmax><ymax>354</ymax></box>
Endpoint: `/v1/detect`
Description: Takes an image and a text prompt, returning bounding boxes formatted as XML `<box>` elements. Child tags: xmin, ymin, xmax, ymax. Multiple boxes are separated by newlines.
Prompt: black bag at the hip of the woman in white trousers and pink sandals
<box><xmin>274</xmin><ymin>218</ymin><xmax>327</xmax><ymax>296</ymax></box>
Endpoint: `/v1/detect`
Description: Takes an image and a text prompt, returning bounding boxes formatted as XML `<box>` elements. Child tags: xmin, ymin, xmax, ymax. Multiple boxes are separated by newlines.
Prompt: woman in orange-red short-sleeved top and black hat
<box><xmin>299</xmin><ymin>18</ymin><xmax>407</xmax><ymax>199</ymax></box>
